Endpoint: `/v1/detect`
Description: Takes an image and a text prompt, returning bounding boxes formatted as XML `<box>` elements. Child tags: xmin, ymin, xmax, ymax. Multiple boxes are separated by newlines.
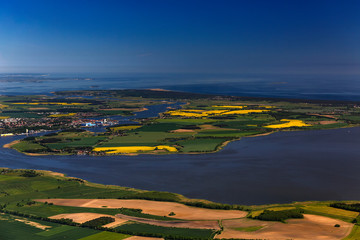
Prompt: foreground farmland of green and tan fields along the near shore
<box><xmin>0</xmin><ymin>169</ymin><xmax>359</xmax><ymax>240</ymax></box>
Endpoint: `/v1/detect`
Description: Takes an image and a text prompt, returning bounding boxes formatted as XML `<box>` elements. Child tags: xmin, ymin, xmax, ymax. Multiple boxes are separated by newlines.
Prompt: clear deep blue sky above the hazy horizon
<box><xmin>0</xmin><ymin>0</ymin><xmax>360</xmax><ymax>74</ymax></box>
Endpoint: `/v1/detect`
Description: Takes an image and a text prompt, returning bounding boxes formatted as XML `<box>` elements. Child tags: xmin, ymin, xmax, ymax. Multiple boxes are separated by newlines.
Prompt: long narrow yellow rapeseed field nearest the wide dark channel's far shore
<box><xmin>93</xmin><ymin>145</ymin><xmax>177</xmax><ymax>154</ymax></box>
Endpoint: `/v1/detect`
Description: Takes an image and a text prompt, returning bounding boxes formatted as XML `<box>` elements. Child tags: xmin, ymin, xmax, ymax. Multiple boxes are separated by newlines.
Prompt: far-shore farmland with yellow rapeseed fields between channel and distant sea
<box><xmin>4</xmin><ymin>90</ymin><xmax>360</xmax><ymax>156</ymax></box>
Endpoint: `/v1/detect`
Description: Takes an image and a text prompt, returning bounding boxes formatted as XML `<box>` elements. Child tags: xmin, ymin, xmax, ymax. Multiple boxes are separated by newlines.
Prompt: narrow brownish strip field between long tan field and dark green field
<box><xmin>116</xmin><ymin>214</ymin><xmax>220</xmax><ymax>230</ymax></box>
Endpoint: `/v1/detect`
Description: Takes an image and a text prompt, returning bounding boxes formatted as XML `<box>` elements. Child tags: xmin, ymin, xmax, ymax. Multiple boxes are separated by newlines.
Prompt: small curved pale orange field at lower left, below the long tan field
<box><xmin>50</xmin><ymin>213</ymin><xmax>127</xmax><ymax>228</ymax></box>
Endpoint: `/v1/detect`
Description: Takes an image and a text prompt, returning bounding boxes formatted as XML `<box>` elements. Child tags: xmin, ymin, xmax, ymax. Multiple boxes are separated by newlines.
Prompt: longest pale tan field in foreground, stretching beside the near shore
<box><xmin>36</xmin><ymin>199</ymin><xmax>247</xmax><ymax>220</ymax></box>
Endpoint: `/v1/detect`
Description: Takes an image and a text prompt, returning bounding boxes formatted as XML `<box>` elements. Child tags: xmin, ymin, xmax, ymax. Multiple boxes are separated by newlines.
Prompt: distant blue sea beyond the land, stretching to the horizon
<box><xmin>0</xmin><ymin>73</ymin><xmax>360</xmax><ymax>101</ymax></box>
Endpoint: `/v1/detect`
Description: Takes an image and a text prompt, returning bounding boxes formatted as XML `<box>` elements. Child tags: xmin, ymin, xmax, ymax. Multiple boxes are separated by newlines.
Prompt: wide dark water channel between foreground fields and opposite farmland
<box><xmin>0</xmin><ymin>127</ymin><xmax>360</xmax><ymax>204</ymax></box>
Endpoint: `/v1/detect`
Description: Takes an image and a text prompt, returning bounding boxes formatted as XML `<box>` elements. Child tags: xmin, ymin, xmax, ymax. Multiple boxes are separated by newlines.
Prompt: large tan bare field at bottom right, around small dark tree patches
<box><xmin>216</xmin><ymin>214</ymin><xmax>353</xmax><ymax>240</ymax></box>
